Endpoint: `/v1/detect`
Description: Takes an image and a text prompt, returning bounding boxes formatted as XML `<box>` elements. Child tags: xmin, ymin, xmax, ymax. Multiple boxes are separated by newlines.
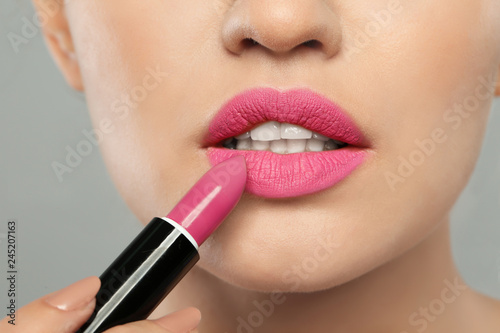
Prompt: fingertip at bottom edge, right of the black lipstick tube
<box><xmin>104</xmin><ymin>308</ymin><xmax>201</xmax><ymax>333</ymax></box>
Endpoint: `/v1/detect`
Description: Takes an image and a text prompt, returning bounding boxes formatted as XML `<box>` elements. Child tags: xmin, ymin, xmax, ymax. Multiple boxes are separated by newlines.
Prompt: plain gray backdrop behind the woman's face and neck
<box><xmin>0</xmin><ymin>0</ymin><xmax>500</xmax><ymax>308</ymax></box>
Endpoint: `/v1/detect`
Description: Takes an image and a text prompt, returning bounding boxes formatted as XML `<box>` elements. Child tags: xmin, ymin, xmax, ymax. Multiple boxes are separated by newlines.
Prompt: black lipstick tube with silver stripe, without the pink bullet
<box><xmin>77</xmin><ymin>218</ymin><xmax>200</xmax><ymax>333</ymax></box>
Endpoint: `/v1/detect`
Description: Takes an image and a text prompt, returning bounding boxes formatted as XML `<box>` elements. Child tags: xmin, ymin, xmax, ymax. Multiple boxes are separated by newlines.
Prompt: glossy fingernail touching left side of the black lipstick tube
<box><xmin>45</xmin><ymin>276</ymin><xmax>101</xmax><ymax>311</ymax></box>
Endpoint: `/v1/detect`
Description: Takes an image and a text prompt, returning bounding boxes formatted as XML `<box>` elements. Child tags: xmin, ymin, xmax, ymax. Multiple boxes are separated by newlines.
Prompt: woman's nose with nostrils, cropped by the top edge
<box><xmin>222</xmin><ymin>0</ymin><xmax>342</xmax><ymax>58</ymax></box>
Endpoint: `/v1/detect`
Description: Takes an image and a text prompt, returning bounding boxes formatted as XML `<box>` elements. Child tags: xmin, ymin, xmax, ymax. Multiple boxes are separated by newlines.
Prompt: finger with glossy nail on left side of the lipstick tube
<box><xmin>0</xmin><ymin>276</ymin><xmax>100</xmax><ymax>333</ymax></box>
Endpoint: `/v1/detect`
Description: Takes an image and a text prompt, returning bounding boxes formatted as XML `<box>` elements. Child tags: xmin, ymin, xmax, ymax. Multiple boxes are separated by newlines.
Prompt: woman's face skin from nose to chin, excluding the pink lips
<box><xmin>45</xmin><ymin>0</ymin><xmax>500</xmax><ymax>291</ymax></box>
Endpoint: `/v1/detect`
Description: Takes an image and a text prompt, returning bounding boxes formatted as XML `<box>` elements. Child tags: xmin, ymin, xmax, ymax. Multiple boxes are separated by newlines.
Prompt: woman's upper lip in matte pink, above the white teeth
<box><xmin>205</xmin><ymin>88</ymin><xmax>367</xmax><ymax>146</ymax></box>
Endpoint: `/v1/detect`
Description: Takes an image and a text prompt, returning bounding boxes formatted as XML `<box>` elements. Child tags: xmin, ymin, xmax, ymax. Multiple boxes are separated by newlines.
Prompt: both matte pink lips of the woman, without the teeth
<box><xmin>205</xmin><ymin>88</ymin><xmax>367</xmax><ymax>198</ymax></box>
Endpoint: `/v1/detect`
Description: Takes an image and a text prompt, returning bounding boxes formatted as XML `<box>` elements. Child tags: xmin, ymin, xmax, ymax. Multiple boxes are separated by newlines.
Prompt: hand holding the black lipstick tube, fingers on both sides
<box><xmin>0</xmin><ymin>276</ymin><xmax>201</xmax><ymax>333</ymax></box>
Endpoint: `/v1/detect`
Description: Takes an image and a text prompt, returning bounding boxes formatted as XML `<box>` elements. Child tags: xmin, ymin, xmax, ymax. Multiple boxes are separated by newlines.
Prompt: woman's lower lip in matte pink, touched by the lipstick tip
<box><xmin>208</xmin><ymin>146</ymin><xmax>367</xmax><ymax>198</ymax></box>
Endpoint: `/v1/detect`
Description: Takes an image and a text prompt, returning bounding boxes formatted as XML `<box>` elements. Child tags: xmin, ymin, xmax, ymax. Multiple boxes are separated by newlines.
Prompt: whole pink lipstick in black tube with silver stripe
<box><xmin>77</xmin><ymin>156</ymin><xmax>246</xmax><ymax>333</ymax></box>
